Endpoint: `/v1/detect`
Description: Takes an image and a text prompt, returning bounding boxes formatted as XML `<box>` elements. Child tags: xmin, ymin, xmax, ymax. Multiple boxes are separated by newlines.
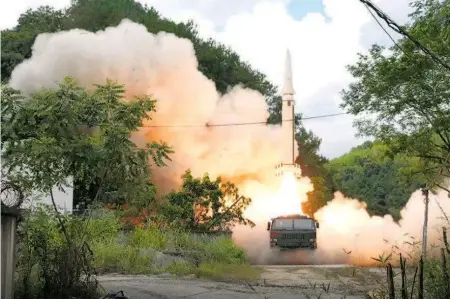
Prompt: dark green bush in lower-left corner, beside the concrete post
<box><xmin>15</xmin><ymin>206</ymin><xmax>103</xmax><ymax>299</ymax></box>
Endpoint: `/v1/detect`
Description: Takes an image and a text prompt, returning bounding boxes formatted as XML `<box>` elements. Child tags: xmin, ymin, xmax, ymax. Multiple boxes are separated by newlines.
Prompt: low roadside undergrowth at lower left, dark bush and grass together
<box><xmin>16</xmin><ymin>206</ymin><xmax>260</xmax><ymax>298</ymax></box>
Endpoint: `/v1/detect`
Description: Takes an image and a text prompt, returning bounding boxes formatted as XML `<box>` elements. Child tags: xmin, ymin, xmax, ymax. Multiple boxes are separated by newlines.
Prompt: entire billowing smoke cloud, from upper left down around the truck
<box><xmin>10</xmin><ymin>20</ymin><xmax>450</xmax><ymax>263</ymax></box>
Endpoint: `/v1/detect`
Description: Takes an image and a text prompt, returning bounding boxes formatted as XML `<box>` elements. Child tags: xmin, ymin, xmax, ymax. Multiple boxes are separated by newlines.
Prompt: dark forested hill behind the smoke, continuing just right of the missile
<box><xmin>1</xmin><ymin>0</ymin><xmax>329</xmax><ymax>218</ymax></box>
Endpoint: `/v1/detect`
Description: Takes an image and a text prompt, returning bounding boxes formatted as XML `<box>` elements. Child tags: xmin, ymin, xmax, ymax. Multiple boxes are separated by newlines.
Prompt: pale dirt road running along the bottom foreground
<box><xmin>99</xmin><ymin>265</ymin><xmax>390</xmax><ymax>299</ymax></box>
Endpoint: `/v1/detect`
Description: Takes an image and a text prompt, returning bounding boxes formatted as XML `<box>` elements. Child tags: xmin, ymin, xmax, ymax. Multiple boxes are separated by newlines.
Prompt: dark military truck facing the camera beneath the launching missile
<box><xmin>267</xmin><ymin>214</ymin><xmax>319</xmax><ymax>249</ymax></box>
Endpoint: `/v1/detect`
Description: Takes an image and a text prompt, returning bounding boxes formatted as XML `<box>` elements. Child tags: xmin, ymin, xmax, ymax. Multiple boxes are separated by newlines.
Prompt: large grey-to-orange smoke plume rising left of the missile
<box><xmin>10</xmin><ymin>20</ymin><xmax>292</xmax><ymax>191</ymax></box>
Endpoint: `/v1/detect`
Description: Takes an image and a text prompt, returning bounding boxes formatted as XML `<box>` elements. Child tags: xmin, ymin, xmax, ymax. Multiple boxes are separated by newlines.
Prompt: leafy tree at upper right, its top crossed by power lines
<box><xmin>342</xmin><ymin>0</ymin><xmax>450</xmax><ymax>192</ymax></box>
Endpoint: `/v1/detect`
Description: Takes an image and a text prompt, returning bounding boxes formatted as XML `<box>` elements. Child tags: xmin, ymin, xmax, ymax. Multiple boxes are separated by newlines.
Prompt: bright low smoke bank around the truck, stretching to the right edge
<box><xmin>235</xmin><ymin>186</ymin><xmax>450</xmax><ymax>265</ymax></box>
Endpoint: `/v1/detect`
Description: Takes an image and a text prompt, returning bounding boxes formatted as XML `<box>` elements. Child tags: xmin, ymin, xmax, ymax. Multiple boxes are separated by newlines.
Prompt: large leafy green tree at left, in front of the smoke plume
<box><xmin>1</xmin><ymin>78</ymin><xmax>172</xmax><ymax>211</ymax></box>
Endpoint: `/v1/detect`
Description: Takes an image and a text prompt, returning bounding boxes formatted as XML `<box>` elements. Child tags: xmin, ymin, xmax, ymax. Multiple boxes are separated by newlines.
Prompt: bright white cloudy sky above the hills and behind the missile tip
<box><xmin>0</xmin><ymin>0</ymin><xmax>410</xmax><ymax>158</ymax></box>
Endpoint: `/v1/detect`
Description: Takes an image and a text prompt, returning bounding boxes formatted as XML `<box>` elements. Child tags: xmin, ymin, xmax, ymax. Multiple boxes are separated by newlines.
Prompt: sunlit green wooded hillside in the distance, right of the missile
<box><xmin>326</xmin><ymin>142</ymin><xmax>425</xmax><ymax>219</ymax></box>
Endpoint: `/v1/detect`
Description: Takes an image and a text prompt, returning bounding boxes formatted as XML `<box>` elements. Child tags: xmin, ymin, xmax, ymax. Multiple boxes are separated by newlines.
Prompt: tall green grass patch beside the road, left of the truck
<box><xmin>84</xmin><ymin>214</ymin><xmax>261</xmax><ymax>280</ymax></box>
